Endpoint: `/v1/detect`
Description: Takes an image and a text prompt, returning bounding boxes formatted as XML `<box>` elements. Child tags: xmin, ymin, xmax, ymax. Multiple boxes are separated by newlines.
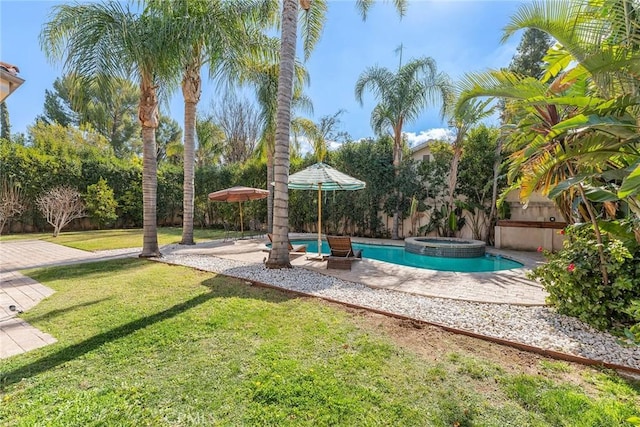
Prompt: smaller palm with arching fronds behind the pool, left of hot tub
<box><xmin>355</xmin><ymin>57</ymin><xmax>452</xmax><ymax>239</ymax></box>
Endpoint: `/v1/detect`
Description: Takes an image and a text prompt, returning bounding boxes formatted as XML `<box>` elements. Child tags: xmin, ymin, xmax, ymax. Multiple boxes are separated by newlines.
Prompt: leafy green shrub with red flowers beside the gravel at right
<box><xmin>530</xmin><ymin>226</ymin><xmax>640</xmax><ymax>331</ymax></box>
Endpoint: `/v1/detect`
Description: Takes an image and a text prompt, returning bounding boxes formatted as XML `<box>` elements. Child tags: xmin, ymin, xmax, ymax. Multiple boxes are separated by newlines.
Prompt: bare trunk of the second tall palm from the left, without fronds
<box><xmin>180</xmin><ymin>63</ymin><xmax>202</xmax><ymax>245</ymax></box>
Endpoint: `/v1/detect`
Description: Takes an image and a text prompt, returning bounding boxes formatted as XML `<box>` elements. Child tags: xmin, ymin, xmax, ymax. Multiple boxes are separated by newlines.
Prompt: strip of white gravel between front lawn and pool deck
<box><xmin>145</xmin><ymin>254</ymin><xmax>640</xmax><ymax>369</ymax></box>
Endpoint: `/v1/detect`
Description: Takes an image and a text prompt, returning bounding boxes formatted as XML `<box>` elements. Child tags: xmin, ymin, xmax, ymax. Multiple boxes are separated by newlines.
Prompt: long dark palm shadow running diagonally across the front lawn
<box><xmin>0</xmin><ymin>276</ymin><xmax>296</xmax><ymax>390</ymax></box>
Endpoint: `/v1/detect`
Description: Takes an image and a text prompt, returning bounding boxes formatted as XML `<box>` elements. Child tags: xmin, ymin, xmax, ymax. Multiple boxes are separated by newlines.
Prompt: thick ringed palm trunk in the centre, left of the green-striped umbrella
<box><xmin>266</xmin><ymin>0</ymin><xmax>298</xmax><ymax>268</ymax></box>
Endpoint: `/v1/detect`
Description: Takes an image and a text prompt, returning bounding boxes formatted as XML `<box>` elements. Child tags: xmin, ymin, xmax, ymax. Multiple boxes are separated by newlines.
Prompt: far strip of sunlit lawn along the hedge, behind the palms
<box><xmin>0</xmin><ymin>227</ymin><xmax>262</xmax><ymax>251</ymax></box>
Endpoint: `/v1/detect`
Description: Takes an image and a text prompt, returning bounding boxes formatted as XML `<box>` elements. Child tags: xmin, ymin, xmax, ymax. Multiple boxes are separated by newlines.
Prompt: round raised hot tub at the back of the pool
<box><xmin>404</xmin><ymin>237</ymin><xmax>486</xmax><ymax>258</ymax></box>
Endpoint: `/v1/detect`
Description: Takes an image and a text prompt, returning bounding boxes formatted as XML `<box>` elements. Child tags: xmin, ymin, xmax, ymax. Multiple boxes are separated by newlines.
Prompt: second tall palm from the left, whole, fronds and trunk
<box><xmin>149</xmin><ymin>0</ymin><xmax>275</xmax><ymax>245</ymax></box>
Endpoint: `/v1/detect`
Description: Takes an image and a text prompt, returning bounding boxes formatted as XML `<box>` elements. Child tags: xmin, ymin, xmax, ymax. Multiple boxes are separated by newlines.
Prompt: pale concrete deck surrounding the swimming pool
<box><xmin>165</xmin><ymin>234</ymin><xmax>548</xmax><ymax>305</ymax></box>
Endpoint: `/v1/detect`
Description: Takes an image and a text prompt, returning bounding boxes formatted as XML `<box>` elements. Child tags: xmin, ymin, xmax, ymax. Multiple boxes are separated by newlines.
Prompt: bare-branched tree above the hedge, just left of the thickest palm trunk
<box><xmin>213</xmin><ymin>94</ymin><xmax>260</xmax><ymax>163</ymax></box>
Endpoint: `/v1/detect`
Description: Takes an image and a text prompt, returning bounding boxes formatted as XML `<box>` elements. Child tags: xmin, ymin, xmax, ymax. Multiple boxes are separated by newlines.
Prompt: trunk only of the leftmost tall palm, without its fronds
<box><xmin>138</xmin><ymin>76</ymin><xmax>161</xmax><ymax>258</ymax></box>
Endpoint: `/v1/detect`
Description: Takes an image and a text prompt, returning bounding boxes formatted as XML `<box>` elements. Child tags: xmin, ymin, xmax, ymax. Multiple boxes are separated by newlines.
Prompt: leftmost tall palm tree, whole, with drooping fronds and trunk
<box><xmin>40</xmin><ymin>1</ymin><xmax>179</xmax><ymax>257</ymax></box>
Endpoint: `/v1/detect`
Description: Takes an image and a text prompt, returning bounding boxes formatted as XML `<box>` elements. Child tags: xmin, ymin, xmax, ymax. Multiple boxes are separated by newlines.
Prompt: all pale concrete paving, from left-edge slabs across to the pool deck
<box><xmin>0</xmin><ymin>236</ymin><xmax>547</xmax><ymax>359</ymax></box>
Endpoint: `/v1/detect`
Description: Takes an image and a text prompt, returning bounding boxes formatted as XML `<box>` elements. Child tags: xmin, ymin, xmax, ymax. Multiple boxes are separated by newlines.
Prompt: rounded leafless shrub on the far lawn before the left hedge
<box><xmin>36</xmin><ymin>186</ymin><xmax>87</xmax><ymax>237</ymax></box>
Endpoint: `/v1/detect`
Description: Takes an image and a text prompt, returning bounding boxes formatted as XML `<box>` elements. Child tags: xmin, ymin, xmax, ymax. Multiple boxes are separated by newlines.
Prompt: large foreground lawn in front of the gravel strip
<box><xmin>0</xmin><ymin>259</ymin><xmax>640</xmax><ymax>427</ymax></box>
